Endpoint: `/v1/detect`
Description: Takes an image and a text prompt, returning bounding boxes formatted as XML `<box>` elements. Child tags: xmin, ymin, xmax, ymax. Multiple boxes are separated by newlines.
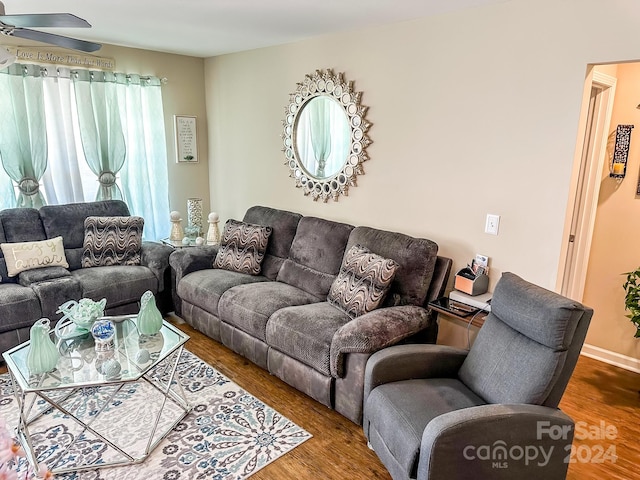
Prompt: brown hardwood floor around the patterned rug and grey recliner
<box><xmin>171</xmin><ymin>318</ymin><xmax>640</xmax><ymax>480</ymax></box>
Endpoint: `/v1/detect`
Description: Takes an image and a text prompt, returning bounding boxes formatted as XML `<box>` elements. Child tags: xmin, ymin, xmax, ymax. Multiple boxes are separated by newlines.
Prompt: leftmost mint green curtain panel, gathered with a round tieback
<box><xmin>0</xmin><ymin>64</ymin><xmax>47</xmax><ymax>208</ymax></box>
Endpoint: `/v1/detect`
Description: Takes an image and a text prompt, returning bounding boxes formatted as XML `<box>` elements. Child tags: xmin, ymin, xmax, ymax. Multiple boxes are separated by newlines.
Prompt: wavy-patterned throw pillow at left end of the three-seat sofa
<box><xmin>213</xmin><ymin>220</ymin><xmax>273</xmax><ymax>275</ymax></box>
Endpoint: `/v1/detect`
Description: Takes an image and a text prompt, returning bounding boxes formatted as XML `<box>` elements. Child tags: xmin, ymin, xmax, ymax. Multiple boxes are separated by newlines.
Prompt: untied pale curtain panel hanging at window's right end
<box><xmin>117</xmin><ymin>74</ymin><xmax>169</xmax><ymax>240</ymax></box>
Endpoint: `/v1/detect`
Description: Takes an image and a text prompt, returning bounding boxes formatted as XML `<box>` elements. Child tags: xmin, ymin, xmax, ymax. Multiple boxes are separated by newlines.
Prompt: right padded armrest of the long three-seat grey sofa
<box><xmin>330</xmin><ymin>305</ymin><xmax>433</xmax><ymax>378</ymax></box>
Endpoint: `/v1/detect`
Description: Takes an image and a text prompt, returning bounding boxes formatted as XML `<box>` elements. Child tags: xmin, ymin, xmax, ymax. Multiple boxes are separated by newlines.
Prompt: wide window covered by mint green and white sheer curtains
<box><xmin>0</xmin><ymin>64</ymin><xmax>169</xmax><ymax>240</ymax></box>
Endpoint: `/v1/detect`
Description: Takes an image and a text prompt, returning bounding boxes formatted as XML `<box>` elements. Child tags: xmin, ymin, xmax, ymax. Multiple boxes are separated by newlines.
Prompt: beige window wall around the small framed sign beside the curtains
<box><xmin>2</xmin><ymin>38</ymin><xmax>210</xmax><ymax>225</ymax></box>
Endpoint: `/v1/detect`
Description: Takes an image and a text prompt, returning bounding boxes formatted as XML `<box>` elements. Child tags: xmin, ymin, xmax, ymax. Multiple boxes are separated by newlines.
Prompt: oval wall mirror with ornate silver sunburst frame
<box><xmin>282</xmin><ymin>69</ymin><xmax>371</xmax><ymax>202</ymax></box>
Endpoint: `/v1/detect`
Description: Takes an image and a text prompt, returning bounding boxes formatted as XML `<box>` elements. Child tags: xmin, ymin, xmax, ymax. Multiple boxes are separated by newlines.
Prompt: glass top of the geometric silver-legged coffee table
<box><xmin>3</xmin><ymin>315</ymin><xmax>189</xmax><ymax>392</ymax></box>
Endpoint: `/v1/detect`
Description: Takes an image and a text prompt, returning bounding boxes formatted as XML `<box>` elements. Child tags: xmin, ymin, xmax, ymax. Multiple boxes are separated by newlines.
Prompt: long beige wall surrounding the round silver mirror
<box><xmin>205</xmin><ymin>0</ymin><xmax>640</xmax><ymax>354</ymax></box>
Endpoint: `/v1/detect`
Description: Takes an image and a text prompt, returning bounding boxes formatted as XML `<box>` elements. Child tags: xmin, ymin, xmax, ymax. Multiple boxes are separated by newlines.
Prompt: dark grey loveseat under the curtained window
<box><xmin>0</xmin><ymin>200</ymin><xmax>173</xmax><ymax>351</ymax></box>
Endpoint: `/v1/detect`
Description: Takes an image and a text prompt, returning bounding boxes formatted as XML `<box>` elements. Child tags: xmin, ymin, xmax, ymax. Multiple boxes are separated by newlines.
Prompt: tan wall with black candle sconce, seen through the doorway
<box><xmin>583</xmin><ymin>63</ymin><xmax>640</xmax><ymax>358</ymax></box>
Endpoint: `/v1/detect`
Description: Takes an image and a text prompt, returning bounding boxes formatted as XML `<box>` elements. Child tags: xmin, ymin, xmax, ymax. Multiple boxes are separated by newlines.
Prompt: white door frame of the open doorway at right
<box><xmin>556</xmin><ymin>65</ymin><xmax>617</xmax><ymax>301</ymax></box>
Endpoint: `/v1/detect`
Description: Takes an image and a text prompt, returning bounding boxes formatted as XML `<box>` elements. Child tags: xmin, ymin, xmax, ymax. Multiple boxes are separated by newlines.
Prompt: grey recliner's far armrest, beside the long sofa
<box><xmin>364</xmin><ymin>343</ymin><xmax>469</xmax><ymax>402</ymax></box>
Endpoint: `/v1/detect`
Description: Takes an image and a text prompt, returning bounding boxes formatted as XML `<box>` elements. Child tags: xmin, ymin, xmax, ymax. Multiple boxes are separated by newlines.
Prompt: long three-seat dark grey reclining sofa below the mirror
<box><xmin>169</xmin><ymin>206</ymin><xmax>451</xmax><ymax>423</ymax></box>
